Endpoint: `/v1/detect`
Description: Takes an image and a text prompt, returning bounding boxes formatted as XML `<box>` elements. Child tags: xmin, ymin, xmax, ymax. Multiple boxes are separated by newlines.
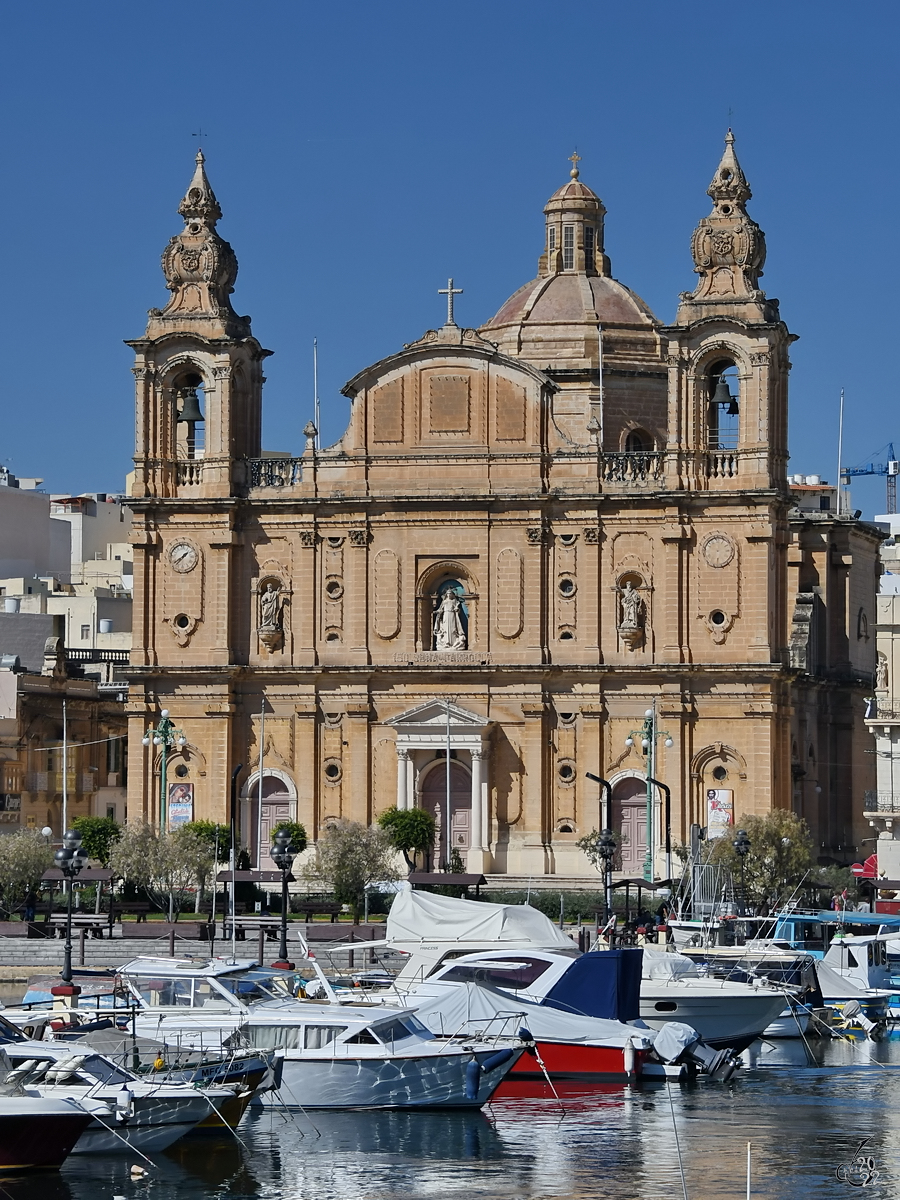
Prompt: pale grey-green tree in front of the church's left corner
<box><xmin>109</xmin><ymin>824</ymin><xmax>215</xmax><ymax>920</ymax></box>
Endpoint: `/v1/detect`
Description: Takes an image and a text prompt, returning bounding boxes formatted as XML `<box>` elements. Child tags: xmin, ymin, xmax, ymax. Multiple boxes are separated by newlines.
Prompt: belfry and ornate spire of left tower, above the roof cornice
<box><xmin>127</xmin><ymin>151</ymin><xmax>270</xmax><ymax>498</ymax></box>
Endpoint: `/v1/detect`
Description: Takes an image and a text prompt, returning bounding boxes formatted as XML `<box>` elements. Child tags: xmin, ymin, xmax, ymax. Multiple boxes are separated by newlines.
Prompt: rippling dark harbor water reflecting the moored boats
<box><xmin>0</xmin><ymin>1037</ymin><xmax>900</xmax><ymax>1200</ymax></box>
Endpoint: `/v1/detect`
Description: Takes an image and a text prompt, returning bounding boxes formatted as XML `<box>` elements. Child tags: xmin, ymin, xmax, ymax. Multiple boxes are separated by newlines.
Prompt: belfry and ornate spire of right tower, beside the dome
<box><xmin>665</xmin><ymin>130</ymin><xmax>794</xmax><ymax>492</ymax></box>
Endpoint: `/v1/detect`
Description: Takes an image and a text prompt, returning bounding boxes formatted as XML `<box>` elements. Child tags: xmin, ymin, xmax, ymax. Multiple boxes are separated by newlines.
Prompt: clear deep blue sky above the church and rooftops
<box><xmin>0</xmin><ymin>0</ymin><xmax>900</xmax><ymax>515</ymax></box>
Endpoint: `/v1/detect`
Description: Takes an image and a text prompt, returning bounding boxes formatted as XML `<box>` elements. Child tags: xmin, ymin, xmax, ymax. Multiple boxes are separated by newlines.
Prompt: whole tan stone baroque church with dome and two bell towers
<box><xmin>128</xmin><ymin>132</ymin><xmax>871</xmax><ymax>878</ymax></box>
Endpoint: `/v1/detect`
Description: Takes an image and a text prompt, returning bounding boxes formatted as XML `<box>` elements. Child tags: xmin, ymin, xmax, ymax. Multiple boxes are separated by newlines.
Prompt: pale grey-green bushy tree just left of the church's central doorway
<box><xmin>304</xmin><ymin>821</ymin><xmax>401</xmax><ymax>922</ymax></box>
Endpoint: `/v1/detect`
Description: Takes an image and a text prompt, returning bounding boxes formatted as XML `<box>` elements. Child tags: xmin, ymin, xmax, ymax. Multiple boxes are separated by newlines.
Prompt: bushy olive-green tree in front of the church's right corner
<box><xmin>709</xmin><ymin>809</ymin><xmax>815</xmax><ymax>912</ymax></box>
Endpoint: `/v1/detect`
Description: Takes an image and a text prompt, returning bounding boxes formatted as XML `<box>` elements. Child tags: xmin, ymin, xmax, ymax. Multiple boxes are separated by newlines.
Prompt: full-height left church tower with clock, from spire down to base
<box><xmin>128</xmin><ymin>154</ymin><xmax>270</xmax><ymax>823</ymax></box>
